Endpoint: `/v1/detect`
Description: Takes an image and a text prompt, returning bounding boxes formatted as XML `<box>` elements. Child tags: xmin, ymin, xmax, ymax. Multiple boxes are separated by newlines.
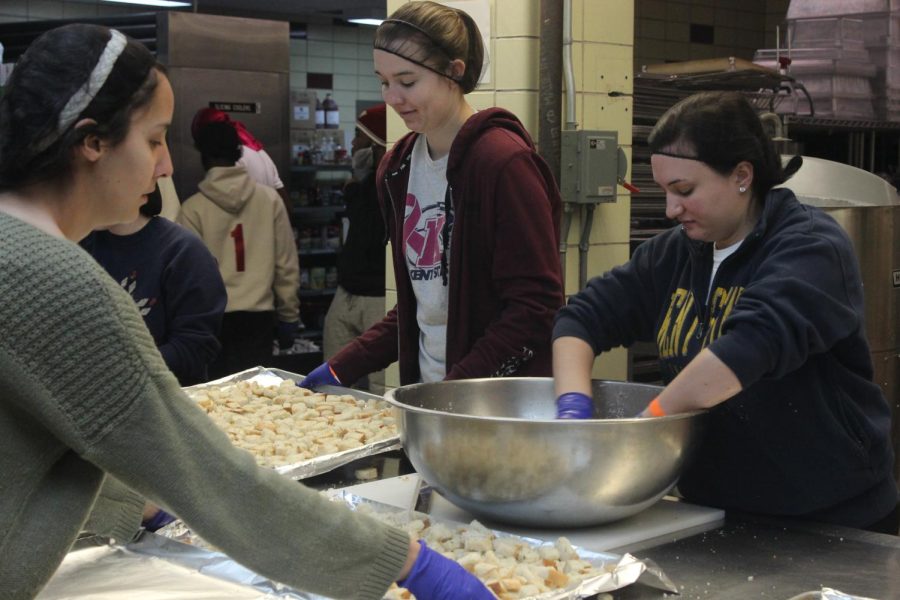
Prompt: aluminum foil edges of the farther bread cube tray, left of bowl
<box><xmin>183</xmin><ymin>367</ymin><xmax>400</xmax><ymax>479</ymax></box>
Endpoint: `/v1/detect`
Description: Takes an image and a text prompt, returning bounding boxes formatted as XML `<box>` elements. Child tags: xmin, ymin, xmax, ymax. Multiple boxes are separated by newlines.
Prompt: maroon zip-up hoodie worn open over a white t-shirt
<box><xmin>329</xmin><ymin>108</ymin><xmax>564</xmax><ymax>385</ymax></box>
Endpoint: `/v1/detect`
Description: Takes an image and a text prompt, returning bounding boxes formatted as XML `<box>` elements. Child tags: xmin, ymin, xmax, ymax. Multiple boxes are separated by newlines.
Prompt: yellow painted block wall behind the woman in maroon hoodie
<box><xmin>385</xmin><ymin>0</ymin><xmax>634</xmax><ymax>387</ymax></box>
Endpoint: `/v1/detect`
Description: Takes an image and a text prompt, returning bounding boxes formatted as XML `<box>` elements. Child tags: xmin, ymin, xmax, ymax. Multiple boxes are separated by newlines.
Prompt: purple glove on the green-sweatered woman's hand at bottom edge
<box><xmin>397</xmin><ymin>540</ymin><xmax>496</xmax><ymax>600</ymax></box>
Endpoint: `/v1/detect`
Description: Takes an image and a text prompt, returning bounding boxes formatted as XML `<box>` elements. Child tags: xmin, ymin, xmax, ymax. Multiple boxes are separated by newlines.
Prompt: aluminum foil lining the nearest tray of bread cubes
<box><xmin>142</xmin><ymin>492</ymin><xmax>678</xmax><ymax>600</ymax></box>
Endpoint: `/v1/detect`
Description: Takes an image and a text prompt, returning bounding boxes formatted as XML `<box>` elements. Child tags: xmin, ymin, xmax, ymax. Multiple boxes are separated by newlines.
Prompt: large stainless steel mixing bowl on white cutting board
<box><xmin>385</xmin><ymin>377</ymin><xmax>703</xmax><ymax>527</ymax></box>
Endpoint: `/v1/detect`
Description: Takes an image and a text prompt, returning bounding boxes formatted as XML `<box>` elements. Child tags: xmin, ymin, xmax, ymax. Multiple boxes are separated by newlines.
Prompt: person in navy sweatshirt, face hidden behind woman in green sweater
<box><xmin>80</xmin><ymin>180</ymin><xmax>227</xmax><ymax>386</ymax></box>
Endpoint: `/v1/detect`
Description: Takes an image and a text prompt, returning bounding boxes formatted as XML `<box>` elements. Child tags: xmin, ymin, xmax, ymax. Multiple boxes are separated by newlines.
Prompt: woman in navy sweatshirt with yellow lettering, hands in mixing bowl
<box><xmin>553</xmin><ymin>92</ymin><xmax>898</xmax><ymax>534</ymax></box>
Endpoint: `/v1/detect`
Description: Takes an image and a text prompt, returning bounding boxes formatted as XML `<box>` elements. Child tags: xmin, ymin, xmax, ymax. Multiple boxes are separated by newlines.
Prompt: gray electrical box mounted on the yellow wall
<box><xmin>560</xmin><ymin>130</ymin><xmax>624</xmax><ymax>204</ymax></box>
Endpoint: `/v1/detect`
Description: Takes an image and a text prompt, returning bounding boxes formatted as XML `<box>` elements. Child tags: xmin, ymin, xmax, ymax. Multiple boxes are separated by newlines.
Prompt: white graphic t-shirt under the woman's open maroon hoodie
<box><xmin>403</xmin><ymin>135</ymin><xmax>453</xmax><ymax>382</ymax></box>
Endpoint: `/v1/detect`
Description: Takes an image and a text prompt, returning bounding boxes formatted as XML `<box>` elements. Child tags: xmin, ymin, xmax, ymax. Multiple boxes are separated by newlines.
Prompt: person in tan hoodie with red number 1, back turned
<box><xmin>178</xmin><ymin>123</ymin><xmax>300</xmax><ymax>379</ymax></box>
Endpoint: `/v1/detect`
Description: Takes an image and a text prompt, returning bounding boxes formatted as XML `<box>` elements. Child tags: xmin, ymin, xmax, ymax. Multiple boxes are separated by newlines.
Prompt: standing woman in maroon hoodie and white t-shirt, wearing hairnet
<box><xmin>302</xmin><ymin>2</ymin><xmax>563</xmax><ymax>387</ymax></box>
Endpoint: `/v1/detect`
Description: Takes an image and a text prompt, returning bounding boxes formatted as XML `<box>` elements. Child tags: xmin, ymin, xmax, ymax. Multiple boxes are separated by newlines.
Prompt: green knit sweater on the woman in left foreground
<box><xmin>0</xmin><ymin>213</ymin><xmax>408</xmax><ymax>599</ymax></box>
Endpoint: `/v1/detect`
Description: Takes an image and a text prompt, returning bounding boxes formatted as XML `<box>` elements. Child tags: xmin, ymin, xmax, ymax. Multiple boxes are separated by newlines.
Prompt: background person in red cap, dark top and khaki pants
<box><xmin>322</xmin><ymin>104</ymin><xmax>387</xmax><ymax>393</ymax></box>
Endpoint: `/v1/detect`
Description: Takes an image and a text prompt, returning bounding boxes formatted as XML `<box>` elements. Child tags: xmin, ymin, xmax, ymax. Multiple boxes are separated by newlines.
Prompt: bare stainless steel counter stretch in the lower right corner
<box><xmin>612</xmin><ymin>515</ymin><xmax>900</xmax><ymax>600</ymax></box>
